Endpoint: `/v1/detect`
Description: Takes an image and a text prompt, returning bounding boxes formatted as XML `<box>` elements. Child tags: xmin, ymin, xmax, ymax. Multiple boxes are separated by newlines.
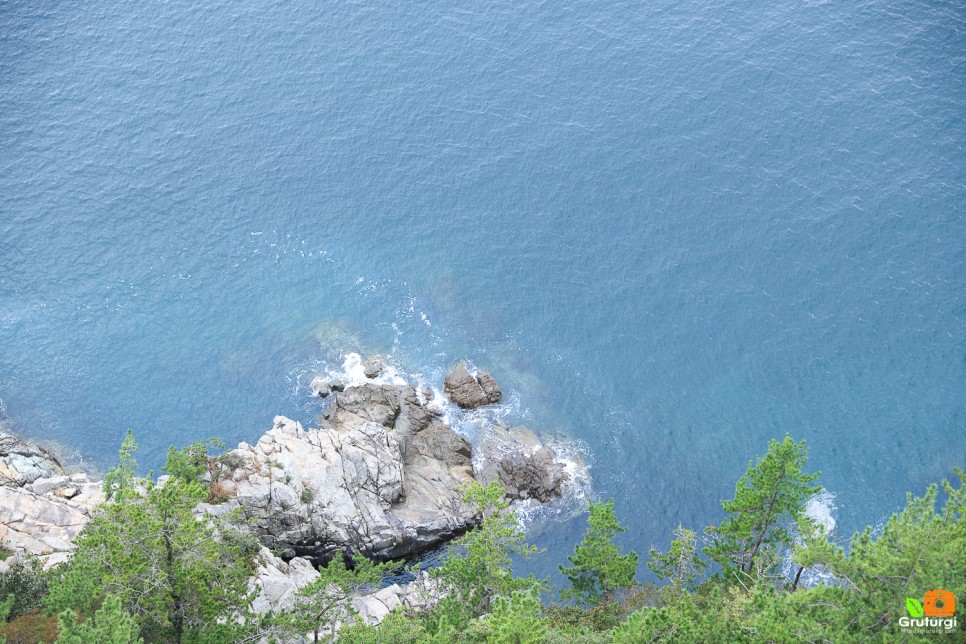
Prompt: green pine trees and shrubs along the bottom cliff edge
<box><xmin>0</xmin><ymin>436</ymin><xmax>966</xmax><ymax>644</ymax></box>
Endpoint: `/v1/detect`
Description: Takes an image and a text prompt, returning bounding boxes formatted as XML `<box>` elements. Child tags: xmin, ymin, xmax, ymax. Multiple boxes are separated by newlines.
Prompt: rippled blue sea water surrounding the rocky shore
<box><xmin>0</xmin><ymin>0</ymin><xmax>966</xmax><ymax>570</ymax></box>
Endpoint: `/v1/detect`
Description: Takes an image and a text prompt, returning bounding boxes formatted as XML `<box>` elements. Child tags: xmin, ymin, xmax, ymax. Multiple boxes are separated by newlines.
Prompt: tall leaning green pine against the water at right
<box><xmin>704</xmin><ymin>434</ymin><xmax>821</xmax><ymax>582</ymax></box>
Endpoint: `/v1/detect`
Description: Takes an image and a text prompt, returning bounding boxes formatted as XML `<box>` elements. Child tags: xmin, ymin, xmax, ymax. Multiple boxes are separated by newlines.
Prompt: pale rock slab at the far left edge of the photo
<box><xmin>0</xmin><ymin>432</ymin><xmax>104</xmax><ymax>567</ymax></box>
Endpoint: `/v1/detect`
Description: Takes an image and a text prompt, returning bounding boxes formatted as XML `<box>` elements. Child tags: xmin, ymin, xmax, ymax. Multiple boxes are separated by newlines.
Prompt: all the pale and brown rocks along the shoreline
<box><xmin>0</xmin><ymin>361</ymin><xmax>586</xmax><ymax>621</ymax></box>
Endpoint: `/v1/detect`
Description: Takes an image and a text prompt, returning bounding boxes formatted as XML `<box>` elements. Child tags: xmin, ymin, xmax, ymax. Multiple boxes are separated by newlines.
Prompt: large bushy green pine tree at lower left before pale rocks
<box><xmin>46</xmin><ymin>432</ymin><xmax>257</xmax><ymax>642</ymax></box>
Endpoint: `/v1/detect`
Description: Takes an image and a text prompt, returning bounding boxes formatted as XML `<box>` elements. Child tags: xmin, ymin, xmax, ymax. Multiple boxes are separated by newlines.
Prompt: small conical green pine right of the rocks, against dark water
<box><xmin>560</xmin><ymin>499</ymin><xmax>638</xmax><ymax>604</ymax></box>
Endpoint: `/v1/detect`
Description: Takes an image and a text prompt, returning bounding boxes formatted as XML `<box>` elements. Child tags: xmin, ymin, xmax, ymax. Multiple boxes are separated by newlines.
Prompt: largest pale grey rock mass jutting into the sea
<box><xmin>206</xmin><ymin>384</ymin><xmax>477</xmax><ymax>559</ymax></box>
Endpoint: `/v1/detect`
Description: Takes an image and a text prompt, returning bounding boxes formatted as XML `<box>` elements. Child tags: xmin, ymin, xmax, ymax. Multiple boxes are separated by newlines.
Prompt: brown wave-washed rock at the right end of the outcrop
<box><xmin>475</xmin><ymin>427</ymin><xmax>568</xmax><ymax>503</ymax></box>
